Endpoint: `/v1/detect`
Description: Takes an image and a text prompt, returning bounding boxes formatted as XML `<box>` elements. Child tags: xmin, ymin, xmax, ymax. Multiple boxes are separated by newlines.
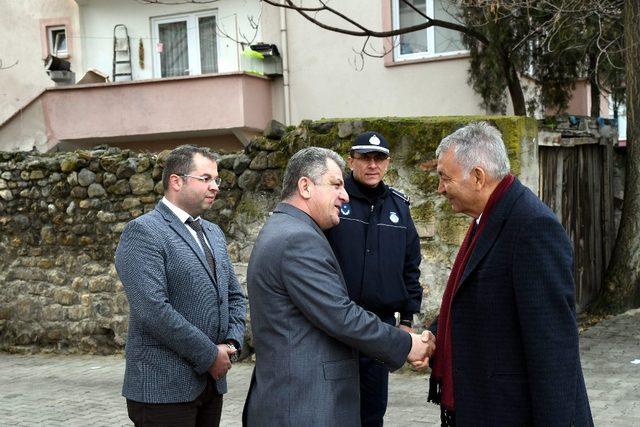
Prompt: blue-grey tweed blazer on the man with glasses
<box><xmin>115</xmin><ymin>202</ymin><xmax>245</xmax><ymax>403</ymax></box>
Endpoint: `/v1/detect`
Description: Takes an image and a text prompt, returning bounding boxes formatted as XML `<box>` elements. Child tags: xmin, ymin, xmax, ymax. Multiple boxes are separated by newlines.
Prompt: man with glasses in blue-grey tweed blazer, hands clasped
<box><xmin>115</xmin><ymin>145</ymin><xmax>245</xmax><ymax>426</ymax></box>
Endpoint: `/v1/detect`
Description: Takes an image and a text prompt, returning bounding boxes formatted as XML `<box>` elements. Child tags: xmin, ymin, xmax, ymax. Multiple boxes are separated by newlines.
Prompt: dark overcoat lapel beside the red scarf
<box><xmin>460</xmin><ymin>179</ymin><xmax>524</xmax><ymax>287</ymax></box>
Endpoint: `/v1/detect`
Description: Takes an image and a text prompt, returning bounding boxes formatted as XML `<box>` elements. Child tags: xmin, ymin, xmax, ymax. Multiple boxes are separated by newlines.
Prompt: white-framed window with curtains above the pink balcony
<box><xmin>151</xmin><ymin>11</ymin><xmax>218</xmax><ymax>77</ymax></box>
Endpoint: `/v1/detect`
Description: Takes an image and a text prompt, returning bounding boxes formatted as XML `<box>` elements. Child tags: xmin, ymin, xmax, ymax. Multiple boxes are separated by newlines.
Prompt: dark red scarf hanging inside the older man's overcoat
<box><xmin>427</xmin><ymin>174</ymin><xmax>515</xmax><ymax>411</ymax></box>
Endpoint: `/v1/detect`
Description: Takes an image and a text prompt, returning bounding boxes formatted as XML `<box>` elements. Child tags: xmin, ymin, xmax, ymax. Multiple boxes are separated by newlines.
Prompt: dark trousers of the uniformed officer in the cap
<box><xmin>360</xmin><ymin>316</ymin><xmax>396</xmax><ymax>427</ymax></box>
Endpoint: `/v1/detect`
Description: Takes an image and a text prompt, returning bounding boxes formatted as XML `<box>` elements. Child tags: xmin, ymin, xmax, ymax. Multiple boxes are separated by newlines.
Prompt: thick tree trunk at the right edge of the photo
<box><xmin>590</xmin><ymin>0</ymin><xmax>640</xmax><ymax>313</ymax></box>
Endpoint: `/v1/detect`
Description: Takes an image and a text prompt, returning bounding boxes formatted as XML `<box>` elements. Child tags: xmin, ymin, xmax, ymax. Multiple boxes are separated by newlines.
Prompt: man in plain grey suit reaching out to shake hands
<box><xmin>244</xmin><ymin>147</ymin><xmax>435</xmax><ymax>427</ymax></box>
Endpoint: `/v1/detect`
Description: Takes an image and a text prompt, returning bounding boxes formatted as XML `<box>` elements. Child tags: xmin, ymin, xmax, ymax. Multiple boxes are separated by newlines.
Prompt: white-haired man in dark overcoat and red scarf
<box><xmin>429</xmin><ymin>122</ymin><xmax>593</xmax><ymax>426</ymax></box>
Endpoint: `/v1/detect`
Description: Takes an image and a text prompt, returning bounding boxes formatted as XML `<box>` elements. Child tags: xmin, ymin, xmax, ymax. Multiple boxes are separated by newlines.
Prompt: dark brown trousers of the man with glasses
<box><xmin>127</xmin><ymin>377</ymin><xmax>222</xmax><ymax>427</ymax></box>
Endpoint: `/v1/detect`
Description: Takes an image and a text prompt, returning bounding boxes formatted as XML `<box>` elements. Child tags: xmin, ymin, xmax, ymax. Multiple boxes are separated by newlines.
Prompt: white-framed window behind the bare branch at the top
<box><xmin>391</xmin><ymin>0</ymin><xmax>467</xmax><ymax>61</ymax></box>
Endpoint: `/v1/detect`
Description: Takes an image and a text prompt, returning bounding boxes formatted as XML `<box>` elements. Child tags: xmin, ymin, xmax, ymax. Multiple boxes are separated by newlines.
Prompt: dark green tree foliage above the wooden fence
<box><xmin>458</xmin><ymin>0</ymin><xmax>624</xmax><ymax>116</ymax></box>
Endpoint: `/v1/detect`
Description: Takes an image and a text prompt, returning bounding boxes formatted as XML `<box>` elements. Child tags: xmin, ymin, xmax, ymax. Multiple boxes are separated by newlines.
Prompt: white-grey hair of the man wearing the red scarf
<box><xmin>436</xmin><ymin>122</ymin><xmax>511</xmax><ymax>179</ymax></box>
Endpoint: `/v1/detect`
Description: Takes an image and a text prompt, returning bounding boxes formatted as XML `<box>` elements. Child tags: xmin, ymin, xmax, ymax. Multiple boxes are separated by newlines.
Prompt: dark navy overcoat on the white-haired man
<box><xmin>430</xmin><ymin>179</ymin><xmax>593</xmax><ymax>426</ymax></box>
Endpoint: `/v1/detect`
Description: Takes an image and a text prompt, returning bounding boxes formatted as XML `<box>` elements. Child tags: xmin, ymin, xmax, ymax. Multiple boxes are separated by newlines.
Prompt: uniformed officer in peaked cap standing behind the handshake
<box><xmin>326</xmin><ymin>132</ymin><xmax>422</xmax><ymax>427</ymax></box>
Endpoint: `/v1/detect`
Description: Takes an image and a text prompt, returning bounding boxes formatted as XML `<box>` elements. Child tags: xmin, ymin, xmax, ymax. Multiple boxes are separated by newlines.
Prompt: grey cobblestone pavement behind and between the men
<box><xmin>0</xmin><ymin>310</ymin><xmax>640</xmax><ymax>427</ymax></box>
